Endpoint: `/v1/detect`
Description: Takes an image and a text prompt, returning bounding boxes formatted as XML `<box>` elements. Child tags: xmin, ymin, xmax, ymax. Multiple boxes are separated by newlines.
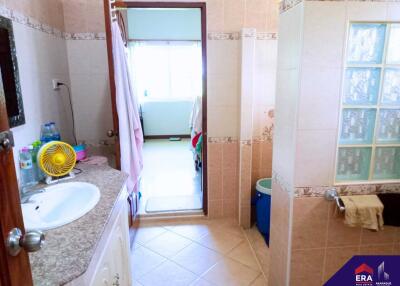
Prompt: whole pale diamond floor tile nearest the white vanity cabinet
<box><xmin>145</xmin><ymin>231</ymin><xmax>192</xmax><ymax>258</ymax></box>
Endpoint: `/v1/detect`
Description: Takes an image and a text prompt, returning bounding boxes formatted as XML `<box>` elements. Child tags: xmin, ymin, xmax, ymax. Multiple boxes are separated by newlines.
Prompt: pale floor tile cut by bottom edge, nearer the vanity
<box><xmin>139</xmin><ymin>261</ymin><xmax>198</xmax><ymax>286</ymax></box>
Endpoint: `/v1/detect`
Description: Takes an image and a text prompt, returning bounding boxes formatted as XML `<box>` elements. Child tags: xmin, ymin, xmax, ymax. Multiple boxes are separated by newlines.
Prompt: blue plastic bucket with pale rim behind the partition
<box><xmin>256</xmin><ymin>178</ymin><xmax>272</xmax><ymax>245</ymax></box>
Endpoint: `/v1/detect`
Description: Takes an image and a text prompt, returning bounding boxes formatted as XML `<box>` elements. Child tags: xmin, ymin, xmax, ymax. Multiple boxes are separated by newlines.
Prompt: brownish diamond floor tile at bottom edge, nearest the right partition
<box><xmin>202</xmin><ymin>258</ymin><xmax>260</xmax><ymax>286</ymax></box>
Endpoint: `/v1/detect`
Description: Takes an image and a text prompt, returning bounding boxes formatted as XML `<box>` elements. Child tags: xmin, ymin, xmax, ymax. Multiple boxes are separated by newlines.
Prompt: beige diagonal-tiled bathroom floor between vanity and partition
<box><xmin>132</xmin><ymin>219</ymin><xmax>268</xmax><ymax>286</ymax></box>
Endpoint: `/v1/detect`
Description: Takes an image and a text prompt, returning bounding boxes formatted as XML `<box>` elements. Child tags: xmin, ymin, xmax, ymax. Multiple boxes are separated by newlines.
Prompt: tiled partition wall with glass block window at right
<box><xmin>269</xmin><ymin>1</ymin><xmax>400</xmax><ymax>286</ymax></box>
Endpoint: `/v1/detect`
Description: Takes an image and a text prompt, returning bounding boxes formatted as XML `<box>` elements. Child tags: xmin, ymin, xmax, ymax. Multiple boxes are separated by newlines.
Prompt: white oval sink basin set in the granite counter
<box><xmin>21</xmin><ymin>182</ymin><xmax>100</xmax><ymax>231</ymax></box>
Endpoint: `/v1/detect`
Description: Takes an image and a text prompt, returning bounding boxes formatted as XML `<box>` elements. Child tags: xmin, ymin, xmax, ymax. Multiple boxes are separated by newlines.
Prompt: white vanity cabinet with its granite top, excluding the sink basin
<box><xmin>29</xmin><ymin>164</ymin><xmax>131</xmax><ymax>286</ymax></box>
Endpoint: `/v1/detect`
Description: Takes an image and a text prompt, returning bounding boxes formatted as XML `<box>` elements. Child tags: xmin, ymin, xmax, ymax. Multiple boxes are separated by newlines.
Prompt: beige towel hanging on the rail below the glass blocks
<box><xmin>340</xmin><ymin>195</ymin><xmax>383</xmax><ymax>231</ymax></box>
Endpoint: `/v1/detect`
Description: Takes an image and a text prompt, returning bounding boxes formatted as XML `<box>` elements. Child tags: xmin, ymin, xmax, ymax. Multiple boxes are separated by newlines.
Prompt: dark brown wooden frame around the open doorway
<box><xmin>104</xmin><ymin>0</ymin><xmax>208</xmax><ymax>215</ymax></box>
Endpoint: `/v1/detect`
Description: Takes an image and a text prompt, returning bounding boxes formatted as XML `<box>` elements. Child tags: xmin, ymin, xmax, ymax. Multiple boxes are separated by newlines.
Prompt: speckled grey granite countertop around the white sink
<box><xmin>29</xmin><ymin>164</ymin><xmax>128</xmax><ymax>286</ymax></box>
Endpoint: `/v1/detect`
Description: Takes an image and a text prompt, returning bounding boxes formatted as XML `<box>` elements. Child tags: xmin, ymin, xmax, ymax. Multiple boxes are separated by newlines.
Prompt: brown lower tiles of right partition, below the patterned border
<box><xmin>290</xmin><ymin>197</ymin><xmax>400</xmax><ymax>286</ymax></box>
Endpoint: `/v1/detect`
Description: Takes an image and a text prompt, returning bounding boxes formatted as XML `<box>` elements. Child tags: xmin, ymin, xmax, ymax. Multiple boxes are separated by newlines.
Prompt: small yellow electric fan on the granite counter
<box><xmin>37</xmin><ymin>141</ymin><xmax>76</xmax><ymax>184</ymax></box>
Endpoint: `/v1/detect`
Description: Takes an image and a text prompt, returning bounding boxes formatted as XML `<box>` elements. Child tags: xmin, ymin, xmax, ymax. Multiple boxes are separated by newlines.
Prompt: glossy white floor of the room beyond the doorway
<box><xmin>139</xmin><ymin>139</ymin><xmax>202</xmax><ymax>215</ymax></box>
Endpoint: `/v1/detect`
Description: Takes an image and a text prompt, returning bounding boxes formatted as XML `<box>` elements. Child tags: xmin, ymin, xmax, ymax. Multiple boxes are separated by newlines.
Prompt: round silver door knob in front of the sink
<box><xmin>6</xmin><ymin>228</ymin><xmax>45</xmax><ymax>256</ymax></box>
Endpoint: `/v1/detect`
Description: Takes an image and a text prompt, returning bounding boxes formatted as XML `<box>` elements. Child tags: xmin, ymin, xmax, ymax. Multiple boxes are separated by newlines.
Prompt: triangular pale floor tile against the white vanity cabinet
<box><xmin>131</xmin><ymin>246</ymin><xmax>165</xmax><ymax>280</ymax></box>
